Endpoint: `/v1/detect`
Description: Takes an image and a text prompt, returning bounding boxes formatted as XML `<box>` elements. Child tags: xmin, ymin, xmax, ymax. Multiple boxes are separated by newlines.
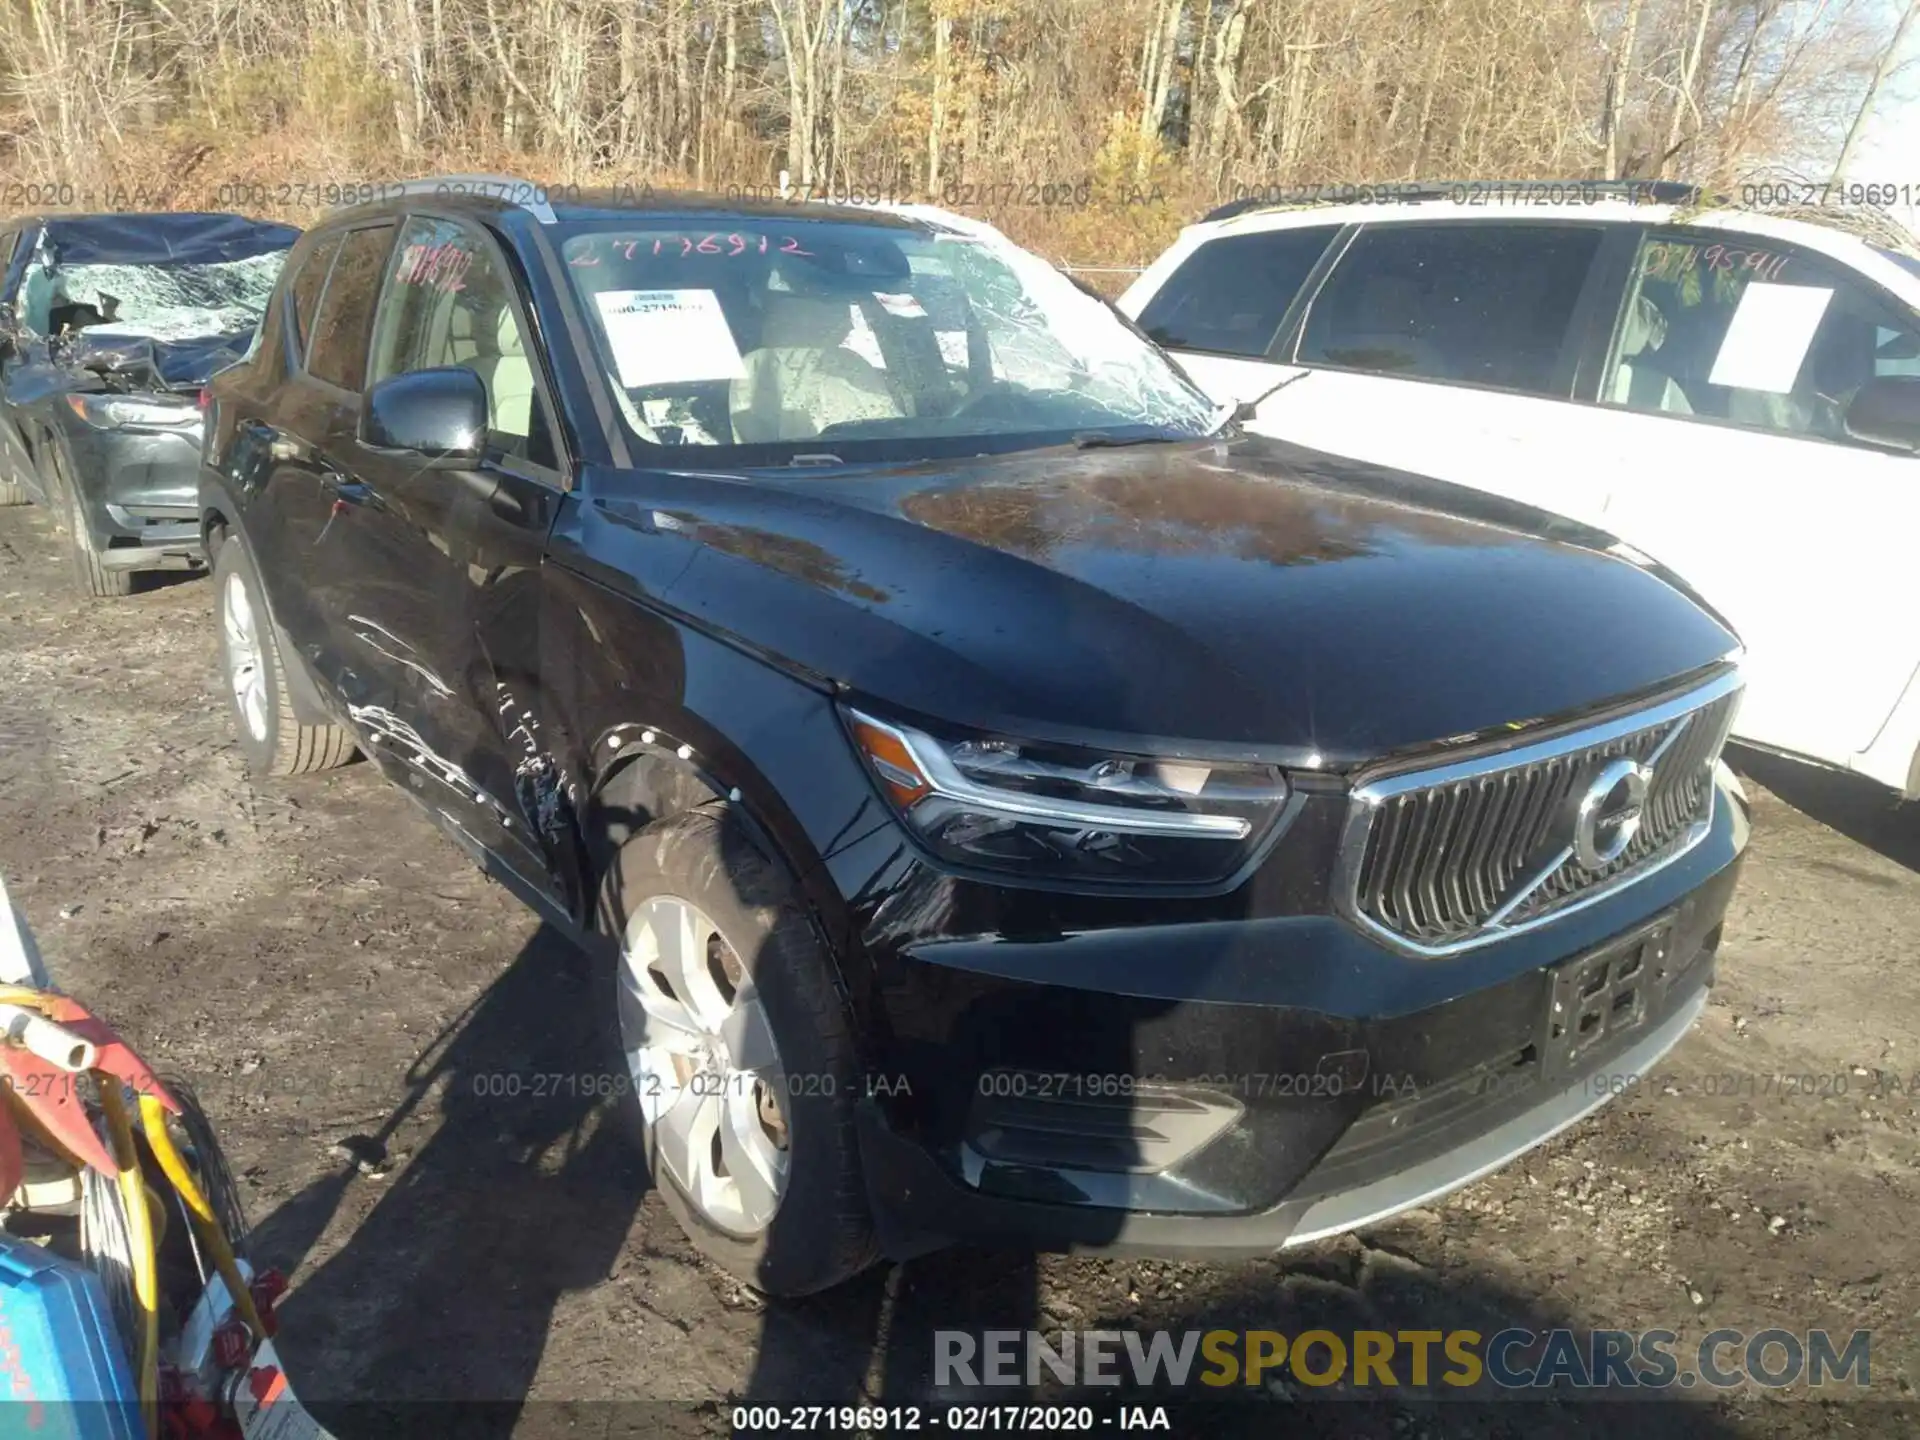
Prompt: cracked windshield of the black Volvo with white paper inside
<box><xmin>564</xmin><ymin>221</ymin><xmax>1215</xmax><ymax>445</ymax></box>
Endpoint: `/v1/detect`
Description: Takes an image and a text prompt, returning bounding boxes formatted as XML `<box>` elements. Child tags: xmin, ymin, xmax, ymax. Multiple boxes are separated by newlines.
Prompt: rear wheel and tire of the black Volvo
<box><xmin>213</xmin><ymin>536</ymin><xmax>355</xmax><ymax>776</ymax></box>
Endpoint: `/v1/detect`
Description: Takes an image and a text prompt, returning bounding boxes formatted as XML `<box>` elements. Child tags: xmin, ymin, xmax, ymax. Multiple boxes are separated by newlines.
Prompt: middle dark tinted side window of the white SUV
<box><xmin>1298</xmin><ymin>225</ymin><xmax>1601</xmax><ymax>396</ymax></box>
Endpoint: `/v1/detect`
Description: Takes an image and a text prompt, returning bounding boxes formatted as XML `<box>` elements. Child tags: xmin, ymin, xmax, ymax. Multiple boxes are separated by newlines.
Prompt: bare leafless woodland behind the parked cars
<box><xmin>0</xmin><ymin>0</ymin><xmax>1896</xmax><ymax>268</ymax></box>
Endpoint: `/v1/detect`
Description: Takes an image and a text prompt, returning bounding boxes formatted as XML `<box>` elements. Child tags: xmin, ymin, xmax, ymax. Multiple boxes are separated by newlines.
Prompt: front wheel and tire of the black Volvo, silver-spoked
<box><xmin>599</xmin><ymin>804</ymin><xmax>877</xmax><ymax>1296</ymax></box>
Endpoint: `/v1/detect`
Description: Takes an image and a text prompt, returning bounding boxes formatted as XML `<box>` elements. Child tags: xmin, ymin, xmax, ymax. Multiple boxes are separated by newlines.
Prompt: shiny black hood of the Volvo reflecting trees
<box><xmin>589</xmin><ymin>438</ymin><xmax>1738</xmax><ymax>766</ymax></box>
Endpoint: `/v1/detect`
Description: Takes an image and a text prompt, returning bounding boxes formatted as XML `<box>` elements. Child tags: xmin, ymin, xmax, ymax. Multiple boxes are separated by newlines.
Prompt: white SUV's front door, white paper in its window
<box><xmin>1592</xmin><ymin>228</ymin><xmax>1920</xmax><ymax>764</ymax></box>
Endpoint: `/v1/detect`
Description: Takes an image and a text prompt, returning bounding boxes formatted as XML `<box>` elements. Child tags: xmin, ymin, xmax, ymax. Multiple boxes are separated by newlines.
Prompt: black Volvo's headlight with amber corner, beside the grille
<box><xmin>847</xmin><ymin>710</ymin><xmax>1286</xmax><ymax>885</ymax></box>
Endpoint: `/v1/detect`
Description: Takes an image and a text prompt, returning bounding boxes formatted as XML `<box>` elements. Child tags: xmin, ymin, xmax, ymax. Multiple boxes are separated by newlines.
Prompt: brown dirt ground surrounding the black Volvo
<box><xmin>0</xmin><ymin>509</ymin><xmax>1920</xmax><ymax>1440</ymax></box>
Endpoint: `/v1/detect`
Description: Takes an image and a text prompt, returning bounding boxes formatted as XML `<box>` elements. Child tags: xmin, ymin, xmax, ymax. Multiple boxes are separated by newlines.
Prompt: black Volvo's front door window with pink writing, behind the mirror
<box><xmin>367</xmin><ymin>217</ymin><xmax>555</xmax><ymax>467</ymax></box>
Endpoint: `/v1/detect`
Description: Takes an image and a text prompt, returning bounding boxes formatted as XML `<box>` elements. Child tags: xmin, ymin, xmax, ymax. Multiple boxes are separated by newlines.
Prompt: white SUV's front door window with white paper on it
<box><xmin>1601</xmin><ymin>230</ymin><xmax>1920</xmax><ymax>442</ymax></box>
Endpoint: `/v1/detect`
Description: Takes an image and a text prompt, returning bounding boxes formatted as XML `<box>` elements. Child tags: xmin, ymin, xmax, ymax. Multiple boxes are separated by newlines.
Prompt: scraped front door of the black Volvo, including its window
<box><xmin>320</xmin><ymin>215</ymin><xmax>570</xmax><ymax>906</ymax></box>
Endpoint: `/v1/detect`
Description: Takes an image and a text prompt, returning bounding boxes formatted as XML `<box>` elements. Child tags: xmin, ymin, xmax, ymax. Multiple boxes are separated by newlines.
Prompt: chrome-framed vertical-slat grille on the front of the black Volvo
<box><xmin>1342</xmin><ymin>672</ymin><xmax>1740</xmax><ymax>952</ymax></box>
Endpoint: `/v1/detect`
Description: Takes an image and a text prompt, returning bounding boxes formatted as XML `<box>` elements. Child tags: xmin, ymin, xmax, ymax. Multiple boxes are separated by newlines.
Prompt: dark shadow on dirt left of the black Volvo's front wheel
<box><xmin>252</xmin><ymin>925</ymin><xmax>645</xmax><ymax>1440</ymax></box>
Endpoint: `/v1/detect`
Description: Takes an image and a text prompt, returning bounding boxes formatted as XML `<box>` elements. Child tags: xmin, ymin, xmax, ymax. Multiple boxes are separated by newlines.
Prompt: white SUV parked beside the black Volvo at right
<box><xmin>1119</xmin><ymin>184</ymin><xmax>1920</xmax><ymax>799</ymax></box>
